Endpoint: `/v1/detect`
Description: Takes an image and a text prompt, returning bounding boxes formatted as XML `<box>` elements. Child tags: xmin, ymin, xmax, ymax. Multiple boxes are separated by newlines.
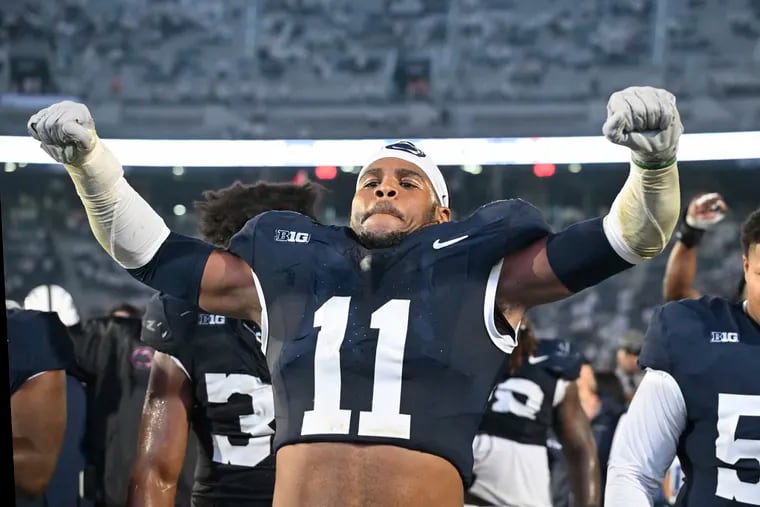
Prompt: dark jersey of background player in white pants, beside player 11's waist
<box><xmin>479</xmin><ymin>340</ymin><xmax>583</xmax><ymax>446</ymax></box>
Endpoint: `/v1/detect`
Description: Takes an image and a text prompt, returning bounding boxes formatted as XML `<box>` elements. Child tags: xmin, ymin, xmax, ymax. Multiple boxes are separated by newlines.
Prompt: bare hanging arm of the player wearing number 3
<box><xmin>127</xmin><ymin>352</ymin><xmax>192</xmax><ymax>507</ymax></box>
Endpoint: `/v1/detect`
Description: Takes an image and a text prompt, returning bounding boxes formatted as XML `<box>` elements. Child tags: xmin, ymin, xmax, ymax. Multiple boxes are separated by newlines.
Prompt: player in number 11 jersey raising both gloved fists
<box><xmin>28</xmin><ymin>87</ymin><xmax>683</xmax><ymax>507</ymax></box>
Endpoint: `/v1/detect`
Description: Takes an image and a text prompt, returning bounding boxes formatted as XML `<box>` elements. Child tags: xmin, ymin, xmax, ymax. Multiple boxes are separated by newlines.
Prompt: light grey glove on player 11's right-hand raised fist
<box><xmin>602</xmin><ymin>86</ymin><xmax>683</xmax><ymax>168</ymax></box>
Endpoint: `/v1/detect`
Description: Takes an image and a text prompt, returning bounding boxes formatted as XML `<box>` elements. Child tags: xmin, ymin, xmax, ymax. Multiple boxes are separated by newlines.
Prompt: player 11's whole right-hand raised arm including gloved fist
<box><xmin>497</xmin><ymin>87</ymin><xmax>683</xmax><ymax>312</ymax></box>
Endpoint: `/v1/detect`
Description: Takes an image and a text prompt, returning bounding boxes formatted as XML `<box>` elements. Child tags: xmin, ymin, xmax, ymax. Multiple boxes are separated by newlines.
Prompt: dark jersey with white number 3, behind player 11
<box><xmin>142</xmin><ymin>295</ymin><xmax>275</xmax><ymax>507</ymax></box>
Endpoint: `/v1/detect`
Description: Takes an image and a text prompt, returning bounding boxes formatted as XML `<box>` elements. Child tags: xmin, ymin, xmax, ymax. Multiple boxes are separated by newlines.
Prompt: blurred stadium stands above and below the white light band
<box><xmin>0</xmin><ymin>0</ymin><xmax>760</xmax><ymax>367</ymax></box>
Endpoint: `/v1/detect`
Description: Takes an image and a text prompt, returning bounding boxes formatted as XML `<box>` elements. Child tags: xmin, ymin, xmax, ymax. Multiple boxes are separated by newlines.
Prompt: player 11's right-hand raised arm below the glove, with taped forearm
<box><xmin>496</xmin><ymin>162</ymin><xmax>680</xmax><ymax>318</ymax></box>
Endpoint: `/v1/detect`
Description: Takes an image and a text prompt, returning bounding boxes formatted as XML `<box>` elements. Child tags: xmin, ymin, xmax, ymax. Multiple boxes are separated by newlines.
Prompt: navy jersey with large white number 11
<box><xmin>230</xmin><ymin>200</ymin><xmax>550</xmax><ymax>484</ymax></box>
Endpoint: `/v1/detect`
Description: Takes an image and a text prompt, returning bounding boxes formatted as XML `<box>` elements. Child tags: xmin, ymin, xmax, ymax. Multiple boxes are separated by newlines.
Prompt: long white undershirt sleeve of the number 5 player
<box><xmin>604</xmin><ymin>370</ymin><xmax>686</xmax><ymax>507</ymax></box>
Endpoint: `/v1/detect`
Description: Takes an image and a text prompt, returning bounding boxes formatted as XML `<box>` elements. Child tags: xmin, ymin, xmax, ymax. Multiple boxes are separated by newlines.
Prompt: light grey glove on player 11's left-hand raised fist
<box><xmin>27</xmin><ymin>100</ymin><xmax>98</xmax><ymax>166</ymax></box>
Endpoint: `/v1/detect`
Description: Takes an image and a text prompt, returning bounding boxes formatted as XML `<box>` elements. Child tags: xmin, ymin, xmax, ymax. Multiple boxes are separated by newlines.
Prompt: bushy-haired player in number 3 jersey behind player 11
<box><xmin>128</xmin><ymin>182</ymin><xmax>322</xmax><ymax>507</ymax></box>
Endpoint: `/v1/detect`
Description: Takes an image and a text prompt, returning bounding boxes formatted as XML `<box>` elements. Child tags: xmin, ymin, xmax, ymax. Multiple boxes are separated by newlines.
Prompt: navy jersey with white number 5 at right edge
<box><xmin>639</xmin><ymin>296</ymin><xmax>760</xmax><ymax>507</ymax></box>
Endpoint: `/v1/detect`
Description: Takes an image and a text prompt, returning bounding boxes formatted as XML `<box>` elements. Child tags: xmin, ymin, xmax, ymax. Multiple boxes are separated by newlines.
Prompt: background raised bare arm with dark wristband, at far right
<box><xmin>662</xmin><ymin>192</ymin><xmax>728</xmax><ymax>301</ymax></box>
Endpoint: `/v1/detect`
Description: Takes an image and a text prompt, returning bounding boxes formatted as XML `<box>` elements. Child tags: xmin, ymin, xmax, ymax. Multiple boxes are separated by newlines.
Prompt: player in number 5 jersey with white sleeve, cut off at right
<box><xmin>605</xmin><ymin>210</ymin><xmax>760</xmax><ymax>507</ymax></box>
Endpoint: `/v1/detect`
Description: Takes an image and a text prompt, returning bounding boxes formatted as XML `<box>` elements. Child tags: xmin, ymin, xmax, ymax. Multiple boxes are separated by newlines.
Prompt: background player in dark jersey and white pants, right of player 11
<box><xmin>467</xmin><ymin>320</ymin><xmax>600</xmax><ymax>507</ymax></box>
